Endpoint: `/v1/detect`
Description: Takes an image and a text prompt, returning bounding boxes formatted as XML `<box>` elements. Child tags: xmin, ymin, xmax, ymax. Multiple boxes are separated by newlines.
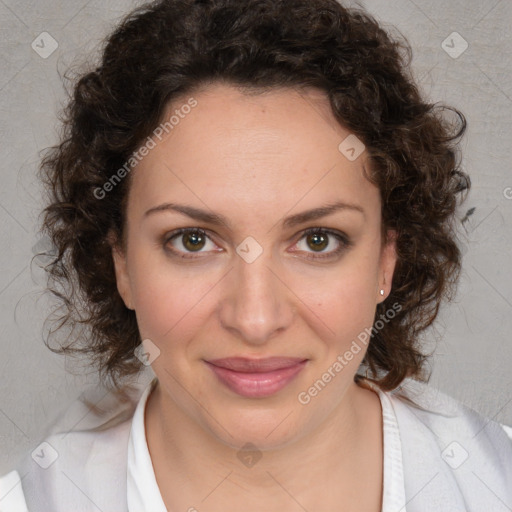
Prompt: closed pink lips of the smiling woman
<box><xmin>206</xmin><ymin>357</ymin><xmax>307</xmax><ymax>398</ymax></box>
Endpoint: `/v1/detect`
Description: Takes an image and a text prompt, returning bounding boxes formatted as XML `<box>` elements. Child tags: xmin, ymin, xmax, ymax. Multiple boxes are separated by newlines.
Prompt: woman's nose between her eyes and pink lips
<box><xmin>220</xmin><ymin>252</ymin><xmax>294</xmax><ymax>345</ymax></box>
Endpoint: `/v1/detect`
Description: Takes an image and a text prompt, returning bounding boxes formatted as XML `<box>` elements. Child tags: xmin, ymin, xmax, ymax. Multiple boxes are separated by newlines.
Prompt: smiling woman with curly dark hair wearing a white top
<box><xmin>1</xmin><ymin>0</ymin><xmax>512</xmax><ymax>512</ymax></box>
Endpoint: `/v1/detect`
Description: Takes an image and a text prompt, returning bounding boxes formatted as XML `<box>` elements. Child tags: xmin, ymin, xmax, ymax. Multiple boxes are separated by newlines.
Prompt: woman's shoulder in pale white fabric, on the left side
<box><xmin>13</xmin><ymin>374</ymin><xmax>151</xmax><ymax>512</ymax></box>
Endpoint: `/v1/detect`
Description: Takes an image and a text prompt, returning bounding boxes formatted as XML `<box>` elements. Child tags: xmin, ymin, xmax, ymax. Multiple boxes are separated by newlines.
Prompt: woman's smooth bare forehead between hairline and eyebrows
<box><xmin>126</xmin><ymin>84</ymin><xmax>379</xmax><ymax>219</ymax></box>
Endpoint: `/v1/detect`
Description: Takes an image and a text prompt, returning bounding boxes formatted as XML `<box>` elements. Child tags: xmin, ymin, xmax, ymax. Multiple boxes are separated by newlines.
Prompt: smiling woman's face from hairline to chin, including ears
<box><xmin>113</xmin><ymin>84</ymin><xmax>396</xmax><ymax>448</ymax></box>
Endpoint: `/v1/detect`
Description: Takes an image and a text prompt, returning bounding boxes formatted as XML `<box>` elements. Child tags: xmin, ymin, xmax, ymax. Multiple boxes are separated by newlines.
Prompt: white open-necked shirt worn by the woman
<box><xmin>4</xmin><ymin>379</ymin><xmax>512</xmax><ymax>512</ymax></box>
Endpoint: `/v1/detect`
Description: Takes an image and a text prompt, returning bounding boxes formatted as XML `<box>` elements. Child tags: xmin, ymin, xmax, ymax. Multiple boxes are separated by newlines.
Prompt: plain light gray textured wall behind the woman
<box><xmin>0</xmin><ymin>0</ymin><xmax>512</xmax><ymax>474</ymax></box>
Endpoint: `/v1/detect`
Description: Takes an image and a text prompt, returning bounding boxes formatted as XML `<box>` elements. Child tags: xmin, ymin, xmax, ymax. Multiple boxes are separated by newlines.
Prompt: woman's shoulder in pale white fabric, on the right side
<box><xmin>385</xmin><ymin>379</ymin><xmax>512</xmax><ymax>510</ymax></box>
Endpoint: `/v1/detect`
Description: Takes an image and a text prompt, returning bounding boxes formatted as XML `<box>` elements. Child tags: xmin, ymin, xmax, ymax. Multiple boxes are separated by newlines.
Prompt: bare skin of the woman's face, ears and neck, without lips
<box><xmin>113</xmin><ymin>84</ymin><xmax>396</xmax><ymax>512</ymax></box>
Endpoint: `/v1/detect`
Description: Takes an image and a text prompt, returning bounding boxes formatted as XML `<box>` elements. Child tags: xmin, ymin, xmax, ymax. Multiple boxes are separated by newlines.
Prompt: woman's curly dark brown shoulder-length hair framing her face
<box><xmin>37</xmin><ymin>0</ymin><xmax>470</xmax><ymax>390</ymax></box>
